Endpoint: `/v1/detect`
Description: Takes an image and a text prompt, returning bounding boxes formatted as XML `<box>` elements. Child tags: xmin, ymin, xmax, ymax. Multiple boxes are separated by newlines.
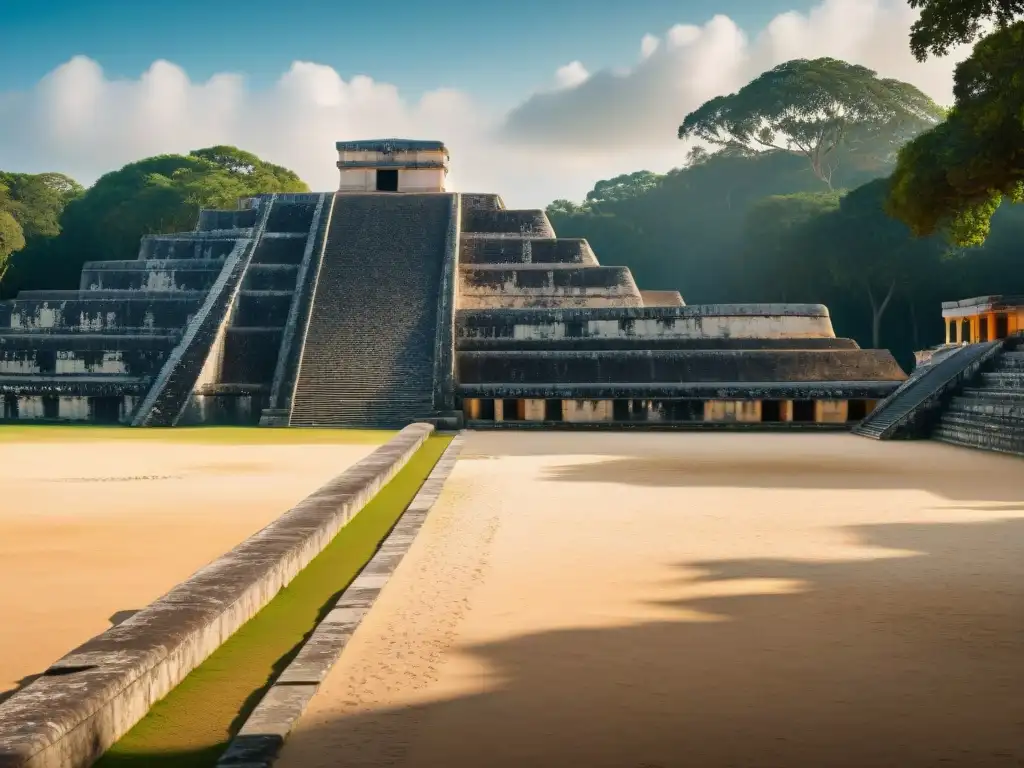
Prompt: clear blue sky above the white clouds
<box><xmin>0</xmin><ymin>0</ymin><xmax>811</xmax><ymax>101</ymax></box>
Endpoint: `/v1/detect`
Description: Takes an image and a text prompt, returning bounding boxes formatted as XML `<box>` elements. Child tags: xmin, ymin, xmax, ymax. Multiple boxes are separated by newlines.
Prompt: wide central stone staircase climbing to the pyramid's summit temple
<box><xmin>289</xmin><ymin>194</ymin><xmax>452</xmax><ymax>427</ymax></box>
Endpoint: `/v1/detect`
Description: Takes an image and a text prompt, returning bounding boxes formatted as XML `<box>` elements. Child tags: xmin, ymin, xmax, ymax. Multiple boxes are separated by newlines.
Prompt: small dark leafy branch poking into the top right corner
<box><xmin>907</xmin><ymin>0</ymin><xmax>1024</xmax><ymax>61</ymax></box>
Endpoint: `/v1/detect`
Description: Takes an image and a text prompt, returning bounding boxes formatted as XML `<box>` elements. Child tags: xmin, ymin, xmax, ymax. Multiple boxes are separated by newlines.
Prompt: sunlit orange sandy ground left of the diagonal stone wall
<box><xmin>0</xmin><ymin>440</ymin><xmax>377</xmax><ymax>700</ymax></box>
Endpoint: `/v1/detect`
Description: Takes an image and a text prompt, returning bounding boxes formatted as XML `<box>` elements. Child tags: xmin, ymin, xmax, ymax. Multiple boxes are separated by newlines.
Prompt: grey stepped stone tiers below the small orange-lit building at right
<box><xmin>931</xmin><ymin>338</ymin><xmax>1024</xmax><ymax>456</ymax></box>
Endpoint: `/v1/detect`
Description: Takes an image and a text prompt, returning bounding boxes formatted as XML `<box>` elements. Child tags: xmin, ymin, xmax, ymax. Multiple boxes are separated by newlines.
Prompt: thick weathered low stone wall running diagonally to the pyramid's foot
<box><xmin>0</xmin><ymin>424</ymin><xmax>432</xmax><ymax>768</ymax></box>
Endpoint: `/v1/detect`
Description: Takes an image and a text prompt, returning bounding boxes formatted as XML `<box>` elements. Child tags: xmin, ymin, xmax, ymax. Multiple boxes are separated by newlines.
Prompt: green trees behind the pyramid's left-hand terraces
<box><xmin>0</xmin><ymin>146</ymin><xmax>309</xmax><ymax>297</ymax></box>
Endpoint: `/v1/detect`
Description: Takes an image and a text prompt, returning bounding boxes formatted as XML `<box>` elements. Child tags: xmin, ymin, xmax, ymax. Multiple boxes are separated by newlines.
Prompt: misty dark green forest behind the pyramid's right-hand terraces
<box><xmin>549</xmin><ymin>144</ymin><xmax>1024</xmax><ymax>368</ymax></box>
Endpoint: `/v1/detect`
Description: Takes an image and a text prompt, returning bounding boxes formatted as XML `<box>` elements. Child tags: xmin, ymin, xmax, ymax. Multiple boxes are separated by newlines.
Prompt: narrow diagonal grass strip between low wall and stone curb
<box><xmin>96</xmin><ymin>435</ymin><xmax>452</xmax><ymax>768</ymax></box>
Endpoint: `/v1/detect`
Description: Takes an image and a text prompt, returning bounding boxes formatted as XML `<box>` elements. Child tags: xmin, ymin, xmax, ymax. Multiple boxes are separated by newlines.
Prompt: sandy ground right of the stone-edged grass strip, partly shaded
<box><xmin>276</xmin><ymin>433</ymin><xmax>1024</xmax><ymax>768</ymax></box>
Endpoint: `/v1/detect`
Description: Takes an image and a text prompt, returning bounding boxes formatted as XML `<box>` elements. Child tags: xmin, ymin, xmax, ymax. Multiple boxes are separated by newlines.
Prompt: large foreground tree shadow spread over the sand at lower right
<box><xmin>110</xmin><ymin>519</ymin><xmax>1024</xmax><ymax>768</ymax></box>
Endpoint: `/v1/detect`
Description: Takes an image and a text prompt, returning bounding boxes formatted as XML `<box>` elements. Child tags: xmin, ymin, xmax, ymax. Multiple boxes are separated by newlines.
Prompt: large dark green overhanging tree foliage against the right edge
<box><xmin>888</xmin><ymin>22</ymin><xmax>1024</xmax><ymax>245</ymax></box>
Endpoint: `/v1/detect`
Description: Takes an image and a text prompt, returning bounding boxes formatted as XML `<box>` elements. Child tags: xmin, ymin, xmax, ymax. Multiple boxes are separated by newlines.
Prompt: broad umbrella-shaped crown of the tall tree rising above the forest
<box><xmin>678</xmin><ymin>58</ymin><xmax>942</xmax><ymax>188</ymax></box>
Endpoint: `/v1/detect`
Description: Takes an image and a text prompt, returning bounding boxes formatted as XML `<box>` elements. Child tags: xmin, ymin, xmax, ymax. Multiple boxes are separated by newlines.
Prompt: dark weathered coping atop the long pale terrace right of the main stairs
<box><xmin>459</xmin><ymin>304</ymin><xmax>828</xmax><ymax>326</ymax></box>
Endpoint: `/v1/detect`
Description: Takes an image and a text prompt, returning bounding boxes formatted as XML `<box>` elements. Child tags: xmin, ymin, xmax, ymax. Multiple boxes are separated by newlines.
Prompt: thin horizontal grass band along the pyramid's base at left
<box><xmin>0</xmin><ymin>424</ymin><xmax>395</xmax><ymax>445</ymax></box>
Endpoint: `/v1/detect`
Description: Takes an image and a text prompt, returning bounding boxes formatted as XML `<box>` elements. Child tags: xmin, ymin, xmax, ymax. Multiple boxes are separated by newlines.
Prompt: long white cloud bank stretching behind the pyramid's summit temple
<box><xmin>0</xmin><ymin>0</ymin><xmax>964</xmax><ymax>206</ymax></box>
